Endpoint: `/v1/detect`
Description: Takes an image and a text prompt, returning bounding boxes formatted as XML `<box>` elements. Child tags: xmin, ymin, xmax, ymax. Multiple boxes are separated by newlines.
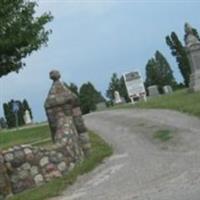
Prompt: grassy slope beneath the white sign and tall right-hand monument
<box><xmin>110</xmin><ymin>90</ymin><xmax>200</xmax><ymax>117</ymax></box>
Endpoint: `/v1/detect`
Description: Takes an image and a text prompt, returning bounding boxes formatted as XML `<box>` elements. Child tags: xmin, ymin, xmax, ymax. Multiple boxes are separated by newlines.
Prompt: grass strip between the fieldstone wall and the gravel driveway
<box><xmin>9</xmin><ymin>131</ymin><xmax>112</xmax><ymax>200</ymax></box>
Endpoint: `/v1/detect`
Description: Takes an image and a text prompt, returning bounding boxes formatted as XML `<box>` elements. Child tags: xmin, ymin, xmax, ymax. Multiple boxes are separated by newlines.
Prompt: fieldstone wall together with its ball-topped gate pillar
<box><xmin>0</xmin><ymin>70</ymin><xmax>91</xmax><ymax>200</ymax></box>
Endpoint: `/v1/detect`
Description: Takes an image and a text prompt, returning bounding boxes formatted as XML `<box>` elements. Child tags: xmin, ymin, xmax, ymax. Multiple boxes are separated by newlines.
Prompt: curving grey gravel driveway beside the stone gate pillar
<box><xmin>52</xmin><ymin>109</ymin><xmax>200</xmax><ymax>200</ymax></box>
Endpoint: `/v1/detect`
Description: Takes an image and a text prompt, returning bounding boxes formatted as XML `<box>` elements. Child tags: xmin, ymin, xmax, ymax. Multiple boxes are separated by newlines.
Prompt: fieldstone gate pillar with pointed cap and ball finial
<box><xmin>44</xmin><ymin>70</ymin><xmax>90</xmax><ymax>157</ymax></box>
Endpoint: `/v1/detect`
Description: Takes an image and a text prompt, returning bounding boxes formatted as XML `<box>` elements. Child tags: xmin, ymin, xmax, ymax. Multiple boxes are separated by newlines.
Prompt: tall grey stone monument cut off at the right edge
<box><xmin>185</xmin><ymin>23</ymin><xmax>200</xmax><ymax>92</ymax></box>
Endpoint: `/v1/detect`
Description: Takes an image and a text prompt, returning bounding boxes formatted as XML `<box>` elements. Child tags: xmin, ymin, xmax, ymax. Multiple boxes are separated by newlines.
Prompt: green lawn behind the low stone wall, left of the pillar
<box><xmin>0</xmin><ymin>125</ymin><xmax>50</xmax><ymax>149</ymax></box>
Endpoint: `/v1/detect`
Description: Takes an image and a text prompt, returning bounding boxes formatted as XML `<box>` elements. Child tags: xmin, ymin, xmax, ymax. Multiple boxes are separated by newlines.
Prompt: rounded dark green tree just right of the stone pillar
<box><xmin>79</xmin><ymin>82</ymin><xmax>104</xmax><ymax>114</ymax></box>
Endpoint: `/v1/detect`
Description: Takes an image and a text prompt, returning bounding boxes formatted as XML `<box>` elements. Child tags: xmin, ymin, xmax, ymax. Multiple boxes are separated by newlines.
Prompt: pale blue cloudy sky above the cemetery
<box><xmin>0</xmin><ymin>0</ymin><xmax>200</xmax><ymax>121</ymax></box>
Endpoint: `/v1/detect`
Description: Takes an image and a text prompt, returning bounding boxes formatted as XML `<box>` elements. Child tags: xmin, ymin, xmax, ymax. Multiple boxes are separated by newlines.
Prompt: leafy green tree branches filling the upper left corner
<box><xmin>0</xmin><ymin>0</ymin><xmax>53</xmax><ymax>77</ymax></box>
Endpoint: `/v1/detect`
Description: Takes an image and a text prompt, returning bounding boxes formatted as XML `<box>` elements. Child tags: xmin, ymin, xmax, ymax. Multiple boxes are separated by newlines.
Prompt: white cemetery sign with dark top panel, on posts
<box><xmin>123</xmin><ymin>71</ymin><xmax>146</xmax><ymax>103</ymax></box>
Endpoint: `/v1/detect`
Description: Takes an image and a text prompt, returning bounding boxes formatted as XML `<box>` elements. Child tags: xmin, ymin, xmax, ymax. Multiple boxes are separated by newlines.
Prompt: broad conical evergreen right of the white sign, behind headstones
<box><xmin>145</xmin><ymin>51</ymin><xmax>176</xmax><ymax>92</ymax></box>
